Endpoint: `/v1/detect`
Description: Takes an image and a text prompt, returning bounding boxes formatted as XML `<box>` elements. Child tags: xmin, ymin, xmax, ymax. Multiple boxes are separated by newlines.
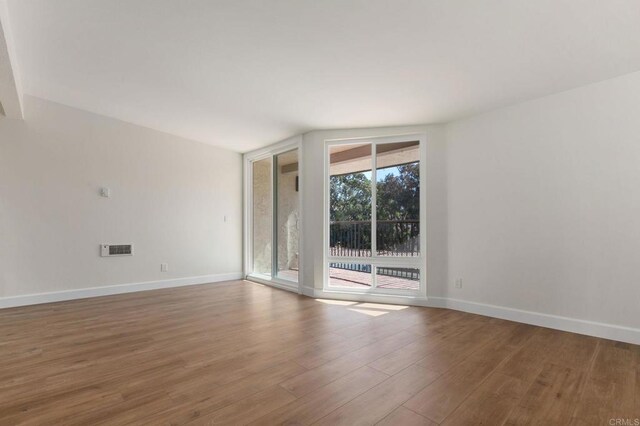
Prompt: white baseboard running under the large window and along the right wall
<box><xmin>302</xmin><ymin>287</ymin><xmax>640</xmax><ymax>345</ymax></box>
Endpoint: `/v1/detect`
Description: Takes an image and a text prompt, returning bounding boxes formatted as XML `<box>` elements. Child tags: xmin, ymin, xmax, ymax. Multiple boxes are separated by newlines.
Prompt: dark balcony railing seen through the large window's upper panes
<box><xmin>329</xmin><ymin>220</ymin><xmax>420</xmax><ymax>257</ymax></box>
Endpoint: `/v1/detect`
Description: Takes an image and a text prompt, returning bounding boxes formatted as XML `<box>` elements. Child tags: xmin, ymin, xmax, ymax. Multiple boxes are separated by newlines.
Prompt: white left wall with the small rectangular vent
<box><xmin>0</xmin><ymin>97</ymin><xmax>242</xmax><ymax>298</ymax></box>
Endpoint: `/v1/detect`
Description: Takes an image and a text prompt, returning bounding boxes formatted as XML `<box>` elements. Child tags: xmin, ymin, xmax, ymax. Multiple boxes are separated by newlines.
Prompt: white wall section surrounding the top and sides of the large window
<box><xmin>301</xmin><ymin>125</ymin><xmax>447</xmax><ymax>296</ymax></box>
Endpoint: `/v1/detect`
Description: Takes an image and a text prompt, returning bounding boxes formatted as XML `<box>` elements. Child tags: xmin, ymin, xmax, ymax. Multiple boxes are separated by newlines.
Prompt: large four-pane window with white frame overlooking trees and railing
<box><xmin>324</xmin><ymin>137</ymin><xmax>425</xmax><ymax>295</ymax></box>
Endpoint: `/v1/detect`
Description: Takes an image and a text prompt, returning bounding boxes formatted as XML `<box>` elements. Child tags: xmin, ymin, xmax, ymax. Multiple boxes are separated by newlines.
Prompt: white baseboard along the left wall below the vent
<box><xmin>0</xmin><ymin>272</ymin><xmax>243</xmax><ymax>309</ymax></box>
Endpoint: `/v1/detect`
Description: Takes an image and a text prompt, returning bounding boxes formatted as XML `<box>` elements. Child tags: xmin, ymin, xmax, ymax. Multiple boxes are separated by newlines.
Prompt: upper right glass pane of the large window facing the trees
<box><xmin>376</xmin><ymin>141</ymin><xmax>420</xmax><ymax>256</ymax></box>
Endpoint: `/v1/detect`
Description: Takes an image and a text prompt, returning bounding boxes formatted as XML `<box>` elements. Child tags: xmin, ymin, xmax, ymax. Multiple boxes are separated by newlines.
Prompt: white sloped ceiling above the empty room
<box><xmin>9</xmin><ymin>0</ymin><xmax>640</xmax><ymax>151</ymax></box>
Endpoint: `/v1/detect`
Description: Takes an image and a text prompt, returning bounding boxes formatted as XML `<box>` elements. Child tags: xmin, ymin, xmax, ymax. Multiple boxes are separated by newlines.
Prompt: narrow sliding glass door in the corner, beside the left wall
<box><xmin>247</xmin><ymin>148</ymin><xmax>300</xmax><ymax>287</ymax></box>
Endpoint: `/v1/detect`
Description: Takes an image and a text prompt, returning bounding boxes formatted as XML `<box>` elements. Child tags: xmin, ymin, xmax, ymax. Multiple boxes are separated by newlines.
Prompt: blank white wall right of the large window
<box><xmin>447</xmin><ymin>73</ymin><xmax>640</xmax><ymax>328</ymax></box>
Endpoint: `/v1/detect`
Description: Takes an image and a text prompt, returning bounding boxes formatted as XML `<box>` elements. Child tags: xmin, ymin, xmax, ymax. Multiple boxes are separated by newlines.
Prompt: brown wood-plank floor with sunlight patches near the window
<box><xmin>0</xmin><ymin>281</ymin><xmax>640</xmax><ymax>425</ymax></box>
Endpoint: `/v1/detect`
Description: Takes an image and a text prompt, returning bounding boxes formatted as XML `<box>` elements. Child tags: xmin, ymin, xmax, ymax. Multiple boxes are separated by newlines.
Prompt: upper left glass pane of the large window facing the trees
<box><xmin>329</xmin><ymin>143</ymin><xmax>372</xmax><ymax>257</ymax></box>
